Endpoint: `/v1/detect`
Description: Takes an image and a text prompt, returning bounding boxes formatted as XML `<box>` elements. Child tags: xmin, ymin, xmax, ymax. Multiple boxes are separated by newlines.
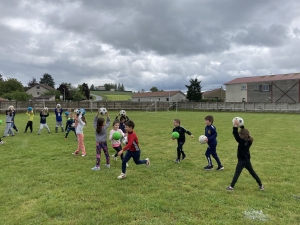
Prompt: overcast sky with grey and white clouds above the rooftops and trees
<box><xmin>0</xmin><ymin>0</ymin><xmax>300</xmax><ymax>91</ymax></box>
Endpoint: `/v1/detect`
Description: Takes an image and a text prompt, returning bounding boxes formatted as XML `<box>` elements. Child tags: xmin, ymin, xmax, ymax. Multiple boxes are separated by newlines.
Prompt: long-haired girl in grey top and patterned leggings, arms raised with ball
<box><xmin>92</xmin><ymin>111</ymin><xmax>110</xmax><ymax>170</ymax></box>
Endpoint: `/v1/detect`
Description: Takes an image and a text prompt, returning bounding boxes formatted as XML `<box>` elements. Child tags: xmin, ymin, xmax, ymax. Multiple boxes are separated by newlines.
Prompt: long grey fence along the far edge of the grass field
<box><xmin>0</xmin><ymin>101</ymin><xmax>300</xmax><ymax>113</ymax></box>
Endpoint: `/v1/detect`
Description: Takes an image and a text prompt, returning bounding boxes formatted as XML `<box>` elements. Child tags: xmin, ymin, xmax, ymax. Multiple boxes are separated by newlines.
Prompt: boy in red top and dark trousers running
<box><xmin>117</xmin><ymin>120</ymin><xmax>150</xmax><ymax>179</ymax></box>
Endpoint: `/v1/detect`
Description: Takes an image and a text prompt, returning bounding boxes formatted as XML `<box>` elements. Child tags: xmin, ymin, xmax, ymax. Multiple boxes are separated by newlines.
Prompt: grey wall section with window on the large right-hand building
<box><xmin>248</xmin><ymin>80</ymin><xmax>299</xmax><ymax>103</ymax></box>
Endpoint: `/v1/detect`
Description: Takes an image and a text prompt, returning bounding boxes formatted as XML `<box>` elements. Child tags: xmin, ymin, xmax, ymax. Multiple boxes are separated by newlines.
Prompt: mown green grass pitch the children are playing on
<box><xmin>0</xmin><ymin>111</ymin><xmax>300</xmax><ymax>225</ymax></box>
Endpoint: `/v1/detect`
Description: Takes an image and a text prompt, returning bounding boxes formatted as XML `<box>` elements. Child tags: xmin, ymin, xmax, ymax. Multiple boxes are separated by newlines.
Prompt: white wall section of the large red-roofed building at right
<box><xmin>226</xmin><ymin>83</ymin><xmax>247</xmax><ymax>102</ymax></box>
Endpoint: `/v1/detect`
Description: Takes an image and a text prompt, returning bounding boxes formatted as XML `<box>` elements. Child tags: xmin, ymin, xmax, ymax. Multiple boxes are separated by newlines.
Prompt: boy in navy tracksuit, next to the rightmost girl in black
<box><xmin>204</xmin><ymin>116</ymin><xmax>224</xmax><ymax>170</ymax></box>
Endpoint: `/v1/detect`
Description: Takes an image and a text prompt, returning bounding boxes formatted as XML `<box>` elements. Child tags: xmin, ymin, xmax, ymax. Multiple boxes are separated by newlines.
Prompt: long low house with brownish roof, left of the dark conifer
<box><xmin>132</xmin><ymin>91</ymin><xmax>186</xmax><ymax>102</ymax></box>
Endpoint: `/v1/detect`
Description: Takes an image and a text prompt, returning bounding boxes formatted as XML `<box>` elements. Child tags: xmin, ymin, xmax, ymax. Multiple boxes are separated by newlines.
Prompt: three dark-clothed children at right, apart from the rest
<box><xmin>172</xmin><ymin>115</ymin><xmax>264</xmax><ymax>191</ymax></box>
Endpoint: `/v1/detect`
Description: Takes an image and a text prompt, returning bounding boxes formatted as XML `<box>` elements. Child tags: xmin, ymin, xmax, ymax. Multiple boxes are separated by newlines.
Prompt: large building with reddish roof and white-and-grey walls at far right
<box><xmin>225</xmin><ymin>73</ymin><xmax>300</xmax><ymax>103</ymax></box>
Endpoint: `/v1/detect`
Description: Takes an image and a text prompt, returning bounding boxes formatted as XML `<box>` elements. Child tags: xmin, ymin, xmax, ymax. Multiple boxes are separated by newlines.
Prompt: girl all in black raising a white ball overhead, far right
<box><xmin>226</xmin><ymin>119</ymin><xmax>264</xmax><ymax>191</ymax></box>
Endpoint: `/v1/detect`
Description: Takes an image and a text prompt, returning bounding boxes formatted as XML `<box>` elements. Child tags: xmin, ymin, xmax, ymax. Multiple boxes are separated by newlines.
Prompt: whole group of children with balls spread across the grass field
<box><xmin>0</xmin><ymin>104</ymin><xmax>264</xmax><ymax>188</ymax></box>
